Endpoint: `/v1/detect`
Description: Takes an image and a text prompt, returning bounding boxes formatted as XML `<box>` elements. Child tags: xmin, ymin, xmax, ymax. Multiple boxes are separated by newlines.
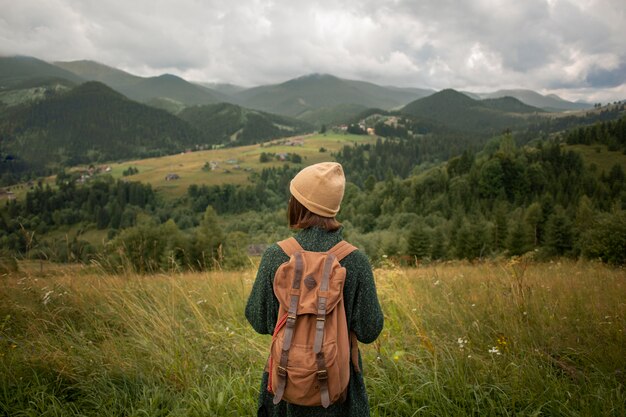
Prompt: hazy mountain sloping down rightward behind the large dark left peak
<box><xmin>55</xmin><ymin>61</ymin><xmax>233</xmax><ymax>106</ymax></box>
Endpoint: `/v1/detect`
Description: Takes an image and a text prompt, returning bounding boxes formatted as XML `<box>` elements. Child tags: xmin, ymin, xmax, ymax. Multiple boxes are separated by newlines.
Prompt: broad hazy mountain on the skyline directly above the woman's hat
<box><xmin>236</xmin><ymin>74</ymin><xmax>430</xmax><ymax>117</ymax></box>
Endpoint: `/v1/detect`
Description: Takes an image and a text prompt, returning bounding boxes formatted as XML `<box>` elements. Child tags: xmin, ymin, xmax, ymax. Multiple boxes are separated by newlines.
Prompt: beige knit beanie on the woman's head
<box><xmin>289</xmin><ymin>162</ymin><xmax>346</xmax><ymax>217</ymax></box>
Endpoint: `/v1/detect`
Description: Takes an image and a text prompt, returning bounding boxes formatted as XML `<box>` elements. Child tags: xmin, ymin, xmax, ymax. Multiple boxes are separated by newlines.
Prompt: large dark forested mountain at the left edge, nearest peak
<box><xmin>0</xmin><ymin>82</ymin><xmax>199</xmax><ymax>174</ymax></box>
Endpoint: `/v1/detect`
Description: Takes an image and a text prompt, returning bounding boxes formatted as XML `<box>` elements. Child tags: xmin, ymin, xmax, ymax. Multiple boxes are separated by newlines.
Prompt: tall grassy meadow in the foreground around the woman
<box><xmin>0</xmin><ymin>258</ymin><xmax>626</xmax><ymax>416</ymax></box>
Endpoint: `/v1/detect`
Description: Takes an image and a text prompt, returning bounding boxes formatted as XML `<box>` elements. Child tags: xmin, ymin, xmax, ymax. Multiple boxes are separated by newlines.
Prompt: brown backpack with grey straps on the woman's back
<box><xmin>268</xmin><ymin>238</ymin><xmax>360</xmax><ymax>407</ymax></box>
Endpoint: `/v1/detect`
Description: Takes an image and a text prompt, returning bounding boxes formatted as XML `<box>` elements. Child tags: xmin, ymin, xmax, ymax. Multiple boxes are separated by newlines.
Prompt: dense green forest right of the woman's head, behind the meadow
<box><xmin>341</xmin><ymin>135</ymin><xmax>626</xmax><ymax>263</ymax></box>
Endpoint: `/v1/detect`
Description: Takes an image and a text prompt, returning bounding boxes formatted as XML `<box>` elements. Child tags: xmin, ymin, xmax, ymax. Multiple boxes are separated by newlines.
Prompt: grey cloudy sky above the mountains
<box><xmin>0</xmin><ymin>0</ymin><xmax>626</xmax><ymax>102</ymax></box>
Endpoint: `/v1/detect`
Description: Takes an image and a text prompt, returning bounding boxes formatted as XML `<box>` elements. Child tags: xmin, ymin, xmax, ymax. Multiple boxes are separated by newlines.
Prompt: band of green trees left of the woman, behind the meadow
<box><xmin>0</xmin><ymin>165</ymin><xmax>300</xmax><ymax>272</ymax></box>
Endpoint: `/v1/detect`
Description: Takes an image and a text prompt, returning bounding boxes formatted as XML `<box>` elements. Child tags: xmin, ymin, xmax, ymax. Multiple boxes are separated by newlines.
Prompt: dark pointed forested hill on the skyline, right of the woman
<box><xmin>401</xmin><ymin>89</ymin><xmax>528</xmax><ymax>133</ymax></box>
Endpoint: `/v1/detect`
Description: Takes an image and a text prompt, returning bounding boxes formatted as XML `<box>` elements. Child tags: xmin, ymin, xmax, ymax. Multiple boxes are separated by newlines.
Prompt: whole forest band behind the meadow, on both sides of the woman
<box><xmin>0</xmin><ymin>134</ymin><xmax>626</xmax><ymax>271</ymax></box>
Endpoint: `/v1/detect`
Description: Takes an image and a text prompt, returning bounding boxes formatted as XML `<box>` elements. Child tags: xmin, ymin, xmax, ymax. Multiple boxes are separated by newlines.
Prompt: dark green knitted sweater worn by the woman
<box><xmin>246</xmin><ymin>228</ymin><xmax>383</xmax><ymax>417</ymax></box>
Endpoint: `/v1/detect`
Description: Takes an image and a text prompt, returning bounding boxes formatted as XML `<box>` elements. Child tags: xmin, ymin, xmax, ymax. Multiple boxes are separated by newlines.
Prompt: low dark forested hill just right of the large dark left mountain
<box><xmin>178</xmin><ymin>103</ymin><xmax>313</xmax><ymax>146</ymax></box>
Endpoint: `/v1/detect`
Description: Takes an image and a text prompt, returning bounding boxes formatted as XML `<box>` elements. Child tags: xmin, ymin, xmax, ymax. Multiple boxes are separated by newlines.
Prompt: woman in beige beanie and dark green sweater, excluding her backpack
<box><xmin>246</xmin><ymin>162</ymin><xmax>383</xmax><ymax>417</ymax></box>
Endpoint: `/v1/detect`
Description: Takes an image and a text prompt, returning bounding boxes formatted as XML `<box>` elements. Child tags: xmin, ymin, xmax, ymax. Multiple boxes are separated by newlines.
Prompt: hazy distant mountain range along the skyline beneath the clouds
<box><xmin>0</xmin><ymin>57</ymin><xmax>592</xmax><ymax>118</ymax></box>
